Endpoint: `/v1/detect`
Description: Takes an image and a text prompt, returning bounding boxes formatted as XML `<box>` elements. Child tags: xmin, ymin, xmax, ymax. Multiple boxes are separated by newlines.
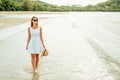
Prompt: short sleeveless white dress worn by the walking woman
<box><xmin>27</xmin><ymin>27</ymin><xmax>42</xmax><ymax>54</ymax></box>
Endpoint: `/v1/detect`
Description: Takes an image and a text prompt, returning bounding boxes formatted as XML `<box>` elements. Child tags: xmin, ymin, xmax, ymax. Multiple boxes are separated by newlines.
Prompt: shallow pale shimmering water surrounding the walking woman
<box><xmin>0</xmin><ymin>12</ymin><xmax>120</xmax><ymax>80</ymax></box>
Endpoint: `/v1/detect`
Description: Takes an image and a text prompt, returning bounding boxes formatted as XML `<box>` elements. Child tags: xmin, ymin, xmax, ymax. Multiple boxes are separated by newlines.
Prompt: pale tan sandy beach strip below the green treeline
<box><xmin>0</xmin><ymin>11</ymin><xmax>119</xmax><ymax>30</ymax></box>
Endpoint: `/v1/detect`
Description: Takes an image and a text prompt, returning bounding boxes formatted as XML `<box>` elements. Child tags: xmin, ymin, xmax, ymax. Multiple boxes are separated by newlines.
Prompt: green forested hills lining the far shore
<box><xmin>0</xmin><ymin>0</ymin><xmax>120</xmax><ymax>12</ymax></box>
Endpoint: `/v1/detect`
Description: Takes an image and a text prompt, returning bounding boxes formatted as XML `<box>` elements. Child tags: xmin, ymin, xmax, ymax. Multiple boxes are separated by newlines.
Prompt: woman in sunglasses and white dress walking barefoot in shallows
<box><xmin>26</xmin><ymin>16</ymin><xmax>45</xmax><ymax>73</ymax></box>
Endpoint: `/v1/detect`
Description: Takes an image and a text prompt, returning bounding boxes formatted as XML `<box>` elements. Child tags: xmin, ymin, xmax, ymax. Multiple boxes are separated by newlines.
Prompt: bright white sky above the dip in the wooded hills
<box><xmin>41</xmin><ymin>0</ymin><xmax>108</xmax><ymax>6</ymax></box>
